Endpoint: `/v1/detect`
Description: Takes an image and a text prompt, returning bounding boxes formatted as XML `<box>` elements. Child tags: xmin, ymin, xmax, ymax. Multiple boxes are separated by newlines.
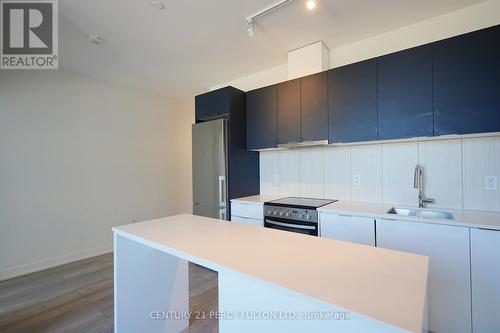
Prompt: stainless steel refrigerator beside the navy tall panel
<box><xmin>192</xmin><ymin>119</ymin><xmax>228</xmax><ymax>220</ymax></box>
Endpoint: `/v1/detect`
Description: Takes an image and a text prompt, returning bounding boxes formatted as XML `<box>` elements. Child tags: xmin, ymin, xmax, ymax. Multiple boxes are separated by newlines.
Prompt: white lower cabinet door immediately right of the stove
<box><xmin>319</xmin><ymin>213</ymin><xmax>375</xmax><ymax>246</ymax></box>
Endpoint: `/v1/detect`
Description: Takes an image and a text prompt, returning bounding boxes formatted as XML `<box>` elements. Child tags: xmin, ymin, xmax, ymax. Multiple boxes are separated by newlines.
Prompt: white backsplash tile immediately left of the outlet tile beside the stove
<box><xmin>323</xmin><ymin>147</ymin><xmax>351</xmax><ymax>200</ymax></box>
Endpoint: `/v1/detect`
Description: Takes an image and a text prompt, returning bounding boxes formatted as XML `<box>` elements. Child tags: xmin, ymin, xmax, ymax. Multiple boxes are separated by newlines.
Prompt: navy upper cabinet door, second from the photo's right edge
<box><xmin>377</xmin><ymin>45</ymin><xmax>434</xmax><ymax>140</ymax></box>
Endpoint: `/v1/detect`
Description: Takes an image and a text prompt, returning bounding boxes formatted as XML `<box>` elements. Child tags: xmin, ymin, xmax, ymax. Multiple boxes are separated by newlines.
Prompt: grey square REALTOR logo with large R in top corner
<box><xmin>0</xmin><ymin>0</ymin><xmax>59</xmax><ymax>69</ymax></box>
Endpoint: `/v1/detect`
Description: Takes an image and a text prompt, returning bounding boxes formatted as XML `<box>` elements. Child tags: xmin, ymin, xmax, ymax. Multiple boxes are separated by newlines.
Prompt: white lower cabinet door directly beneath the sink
<box><xmin>376</xmin><ymin>219</ymin><xmax>470</xmax><ymax>333</ymax></box>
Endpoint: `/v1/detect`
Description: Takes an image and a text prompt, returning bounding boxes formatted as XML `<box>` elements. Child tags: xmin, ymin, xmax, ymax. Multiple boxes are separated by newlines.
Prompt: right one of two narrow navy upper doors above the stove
<box><xmin>300</xmin><ymin>72</ymin><xmax>328</xmax><ymax>141</ymax></box>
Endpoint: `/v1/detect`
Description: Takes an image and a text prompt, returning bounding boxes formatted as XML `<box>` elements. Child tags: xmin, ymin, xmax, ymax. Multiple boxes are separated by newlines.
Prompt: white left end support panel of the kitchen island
<box><xmin>114</xmin><ymin>233</ymin><xmax>189</xmax><ymax>333</ymax></box>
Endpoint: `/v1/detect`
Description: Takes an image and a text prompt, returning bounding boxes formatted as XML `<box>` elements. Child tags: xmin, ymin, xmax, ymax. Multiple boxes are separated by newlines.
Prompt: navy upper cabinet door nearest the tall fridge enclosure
<box><xmin>247</xmin><ymin>85</ymin><xmax>278</xmax><ymax>149</ymax></box>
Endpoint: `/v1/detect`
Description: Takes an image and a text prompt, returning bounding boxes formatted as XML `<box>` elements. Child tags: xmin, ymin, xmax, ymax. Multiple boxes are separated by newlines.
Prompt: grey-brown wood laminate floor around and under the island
<box><xmin>0</xmin><ymin>254</ymin><xmax>218</xmax><ymax>333</ymax></box>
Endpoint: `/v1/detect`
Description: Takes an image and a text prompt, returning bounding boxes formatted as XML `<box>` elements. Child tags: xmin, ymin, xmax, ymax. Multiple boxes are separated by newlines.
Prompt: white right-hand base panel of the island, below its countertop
<box><xmin>219</xmin><ymin>271</ymin><xmax>410</xmax><ymax>333</ymax></box>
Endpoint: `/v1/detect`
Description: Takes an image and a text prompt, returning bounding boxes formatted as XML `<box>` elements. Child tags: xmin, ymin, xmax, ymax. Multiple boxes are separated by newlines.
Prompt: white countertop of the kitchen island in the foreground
<box><xmin>113</xmin><ymin>215</ymin><xmax>428</xmax><ymax>333</ymax></box>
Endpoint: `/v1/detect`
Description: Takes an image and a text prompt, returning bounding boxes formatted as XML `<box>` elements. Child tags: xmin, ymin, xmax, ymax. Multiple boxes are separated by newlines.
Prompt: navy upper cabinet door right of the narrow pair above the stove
<box><xmin>328</xmin><ymin>59</ymin><xmax>377</xmax><ymax>143</ymax></box>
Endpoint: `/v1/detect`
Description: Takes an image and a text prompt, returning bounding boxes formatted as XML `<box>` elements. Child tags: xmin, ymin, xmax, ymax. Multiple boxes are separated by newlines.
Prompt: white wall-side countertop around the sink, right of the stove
<box><xmin>318</xmin><ymin>200</ymin><xmax>500</xmax><ymax>230</ymax></box>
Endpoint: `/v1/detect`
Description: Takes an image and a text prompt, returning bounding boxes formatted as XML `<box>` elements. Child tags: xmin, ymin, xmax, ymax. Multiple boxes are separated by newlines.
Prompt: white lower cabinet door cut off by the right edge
<box><xmin>470</xmin><ymin>229</ymin><xmax>500</xmax><ymax>333</ymax></box>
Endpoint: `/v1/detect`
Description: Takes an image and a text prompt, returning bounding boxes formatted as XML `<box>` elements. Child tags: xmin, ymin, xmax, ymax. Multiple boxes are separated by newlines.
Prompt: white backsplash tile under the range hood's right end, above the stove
<box><xmin>298</xmin><ymin>148</ymin><xmax>324</xmax><ymax>198</ymax></box>
